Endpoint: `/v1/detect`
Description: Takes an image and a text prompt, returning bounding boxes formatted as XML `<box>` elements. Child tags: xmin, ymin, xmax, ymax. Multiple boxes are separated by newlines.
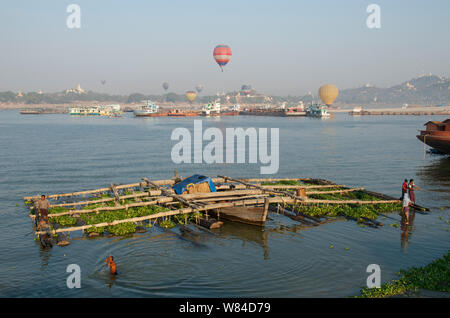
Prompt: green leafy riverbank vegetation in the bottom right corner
<box><xmin>357</xmin><ymin>252</ymin><xmax>450</xmax><ymax>298</ymax></box>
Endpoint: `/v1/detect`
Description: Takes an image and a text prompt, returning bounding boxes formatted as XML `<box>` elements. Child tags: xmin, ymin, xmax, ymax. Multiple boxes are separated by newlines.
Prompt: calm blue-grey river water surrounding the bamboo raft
<box><xmin>0</xmin><ymin>111</ymin><xmax>450</xmax><ymax>297</ymax></box>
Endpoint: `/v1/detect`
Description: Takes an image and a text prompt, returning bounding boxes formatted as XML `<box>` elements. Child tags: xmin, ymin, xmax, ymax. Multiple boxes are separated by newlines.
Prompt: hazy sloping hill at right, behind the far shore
<box><xmin>336</xmin><ymin>75</ymin><xmax>450</xmax><ymax>105</ymax></box>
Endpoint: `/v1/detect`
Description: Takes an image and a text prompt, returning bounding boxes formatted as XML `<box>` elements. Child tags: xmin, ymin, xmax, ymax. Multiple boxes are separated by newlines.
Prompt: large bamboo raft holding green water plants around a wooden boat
<box><xmin>24</xmin><ymin>176</ymin><xmax>426</xmax><ymax>245</ymax></box>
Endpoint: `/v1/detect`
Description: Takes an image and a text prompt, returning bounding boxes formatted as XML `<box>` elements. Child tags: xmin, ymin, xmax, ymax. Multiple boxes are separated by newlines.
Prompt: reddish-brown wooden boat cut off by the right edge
<box><xmin>416</xmin><ymin>118</ymin><xmax>450</xmax><ymax>155</ymax></box>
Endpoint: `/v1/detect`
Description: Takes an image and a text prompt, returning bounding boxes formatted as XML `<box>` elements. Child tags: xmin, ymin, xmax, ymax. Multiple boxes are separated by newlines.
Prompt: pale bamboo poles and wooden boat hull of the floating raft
<box><xmin>24</xmin><ymin>176</ymin><xmax>406</xmax><ymax>240</ymax></box>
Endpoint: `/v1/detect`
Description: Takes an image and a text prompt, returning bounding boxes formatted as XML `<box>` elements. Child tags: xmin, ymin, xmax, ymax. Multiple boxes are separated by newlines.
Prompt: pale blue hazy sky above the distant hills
<box><xmin>0</xmin><ymin>0</ymin><xmax>450</xmax><ymax>95</ymax></box>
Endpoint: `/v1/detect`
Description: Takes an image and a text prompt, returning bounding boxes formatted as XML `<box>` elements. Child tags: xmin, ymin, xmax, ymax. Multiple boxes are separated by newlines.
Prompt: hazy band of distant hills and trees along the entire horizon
<box><xmin>0</xmin><ymin>75</ymin><xmax>450</xmax><ymax>105</ymax></box>
